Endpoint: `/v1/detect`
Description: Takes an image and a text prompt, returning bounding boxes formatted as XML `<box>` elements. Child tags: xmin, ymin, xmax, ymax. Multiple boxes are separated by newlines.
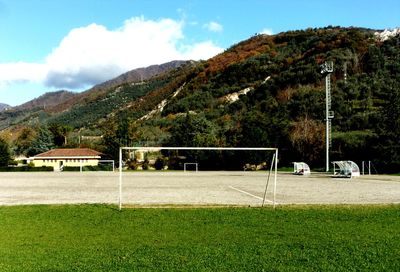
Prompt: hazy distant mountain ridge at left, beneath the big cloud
<box><xmin>0</xmin><ymin>61</ymin><xmax>191</xmax><ymax>130</ymax></box>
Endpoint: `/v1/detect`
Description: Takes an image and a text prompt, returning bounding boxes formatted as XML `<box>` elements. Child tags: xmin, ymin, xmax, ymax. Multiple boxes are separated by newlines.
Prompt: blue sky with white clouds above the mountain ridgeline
<box><xmin>0</xmin><ymin>0</ymin><xmax>400</xmax><ymax>106</ymax></box>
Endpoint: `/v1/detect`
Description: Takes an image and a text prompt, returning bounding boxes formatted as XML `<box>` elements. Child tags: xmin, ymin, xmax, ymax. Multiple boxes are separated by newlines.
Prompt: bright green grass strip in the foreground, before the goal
<box><xmin>0</xmin><ymin>205</ymin><xmax>400</xmax><ymax>271</ymax></box>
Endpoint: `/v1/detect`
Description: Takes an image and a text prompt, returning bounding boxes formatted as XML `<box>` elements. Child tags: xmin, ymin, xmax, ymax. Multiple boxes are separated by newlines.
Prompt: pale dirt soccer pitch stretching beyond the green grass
<box><xmin>0</xmin><ymin>171</ymin><xmax>400</xmax><ymax>206</ymax></box>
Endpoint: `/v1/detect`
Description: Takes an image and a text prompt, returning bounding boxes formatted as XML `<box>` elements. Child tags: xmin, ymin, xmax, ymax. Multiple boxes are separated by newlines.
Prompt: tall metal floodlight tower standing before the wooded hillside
<box><xmin>321</xmin><ymin>61</ymin><xmax>334</xmax><ymax>172</ymax></box>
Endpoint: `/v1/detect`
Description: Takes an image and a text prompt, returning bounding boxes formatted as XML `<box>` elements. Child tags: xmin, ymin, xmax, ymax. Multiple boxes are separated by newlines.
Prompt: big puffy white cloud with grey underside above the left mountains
<box><xmin>0</xmin><ymin>17</ymin><xmax>223</xmax><ymax>89</ymax></box>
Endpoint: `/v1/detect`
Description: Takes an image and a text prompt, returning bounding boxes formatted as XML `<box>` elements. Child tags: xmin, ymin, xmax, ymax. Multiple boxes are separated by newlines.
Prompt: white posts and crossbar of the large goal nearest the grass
<box><xmin>118</xmin><ymin>146</ymin><xmax>278</xmax><ymax>210</ymax></box>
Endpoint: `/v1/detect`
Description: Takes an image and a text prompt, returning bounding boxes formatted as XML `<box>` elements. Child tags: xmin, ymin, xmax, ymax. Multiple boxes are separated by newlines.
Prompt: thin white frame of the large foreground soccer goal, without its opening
<box><xmin>118</xmin><ymin>146</ymin><xmax>278</xmax><ymax>210</ymax></box>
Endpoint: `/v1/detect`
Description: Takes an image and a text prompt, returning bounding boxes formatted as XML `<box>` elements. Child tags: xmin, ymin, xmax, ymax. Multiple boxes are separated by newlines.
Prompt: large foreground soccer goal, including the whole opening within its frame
<box><xmin>118</xmin><ymin>147</ymin><xmax>278</xmax><ymax>209</ymax></box>
